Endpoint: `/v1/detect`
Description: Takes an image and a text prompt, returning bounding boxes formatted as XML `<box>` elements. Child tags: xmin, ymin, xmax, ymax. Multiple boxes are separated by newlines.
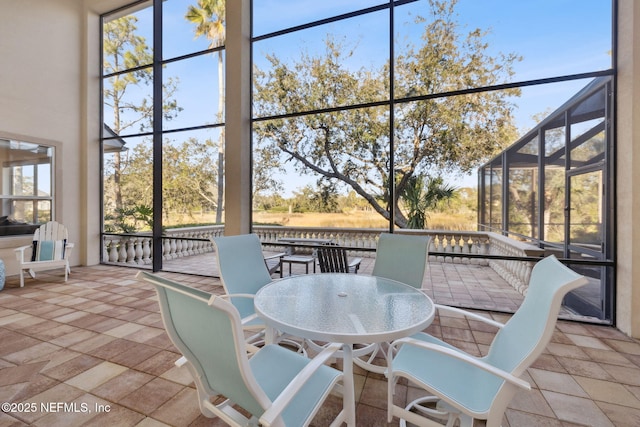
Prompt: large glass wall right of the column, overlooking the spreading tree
<box><xmin>252</xmin><ymin>0</ymin><xmax>612</xmax><ymax>232</ymax></box>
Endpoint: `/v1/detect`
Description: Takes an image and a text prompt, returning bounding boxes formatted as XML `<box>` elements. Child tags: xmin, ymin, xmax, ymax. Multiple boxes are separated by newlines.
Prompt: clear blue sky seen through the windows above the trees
<box><xmin>111</xmin><ymin>0</ymin><xmax>611</xmax><ymax>191</ymax></box>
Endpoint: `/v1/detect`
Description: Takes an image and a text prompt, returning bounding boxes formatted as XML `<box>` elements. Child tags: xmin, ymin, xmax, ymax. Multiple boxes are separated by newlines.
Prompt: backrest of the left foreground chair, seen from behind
<box><xmin>137</xmin><ymin>271</ymin><xmax>270</xmax><ymax>417</ymax></box>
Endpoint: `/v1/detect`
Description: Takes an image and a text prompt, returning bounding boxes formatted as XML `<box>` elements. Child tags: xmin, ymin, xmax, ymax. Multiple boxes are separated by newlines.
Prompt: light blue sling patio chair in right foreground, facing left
<box><xmin>387</xmin><ymin>255</ymin><xmax>587</xmax><ymax>427</ymax></box>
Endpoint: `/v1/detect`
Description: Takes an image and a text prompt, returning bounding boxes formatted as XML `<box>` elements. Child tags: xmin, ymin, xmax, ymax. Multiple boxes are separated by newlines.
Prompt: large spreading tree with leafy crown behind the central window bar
<box><xmin>254</xmin><ymin>0</ymin><xmax>520</xmax><ymax>227</ymax></box>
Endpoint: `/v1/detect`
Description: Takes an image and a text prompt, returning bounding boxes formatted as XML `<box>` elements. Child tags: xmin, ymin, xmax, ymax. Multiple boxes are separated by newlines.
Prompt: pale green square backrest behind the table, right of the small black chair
<box><xmin>371</xmin><ymin>233</ymin><xmax>431</xmax><ymax>289</ymax></box>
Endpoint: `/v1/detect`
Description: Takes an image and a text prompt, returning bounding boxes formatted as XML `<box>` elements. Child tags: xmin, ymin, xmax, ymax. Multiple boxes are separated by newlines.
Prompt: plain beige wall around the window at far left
<box><xmin>0</xmin><ymin>0</ymin><xmax>82</xmax><ymax>274</ymax></box>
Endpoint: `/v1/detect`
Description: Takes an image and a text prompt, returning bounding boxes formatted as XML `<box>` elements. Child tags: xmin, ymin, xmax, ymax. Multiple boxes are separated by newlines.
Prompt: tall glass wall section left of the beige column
<box><xmin>102</xmin><ymin>0</ymin><xmax>225</xmax><ymax>270</ymax></box>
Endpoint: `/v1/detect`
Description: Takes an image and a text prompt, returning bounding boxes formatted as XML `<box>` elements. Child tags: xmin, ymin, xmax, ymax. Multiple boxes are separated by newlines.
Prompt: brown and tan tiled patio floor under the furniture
<box><xmin>0</xmin><ymin>266</ymin><xmax>640</xmax><ymax>427</ymax></box>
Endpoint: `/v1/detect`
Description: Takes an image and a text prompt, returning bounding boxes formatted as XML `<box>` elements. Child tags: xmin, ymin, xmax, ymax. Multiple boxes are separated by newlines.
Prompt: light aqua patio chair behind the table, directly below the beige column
<box><xmin>211</xmin><ymin>234</ymin><xmax>303</xmax><ymax>351</ymax></box>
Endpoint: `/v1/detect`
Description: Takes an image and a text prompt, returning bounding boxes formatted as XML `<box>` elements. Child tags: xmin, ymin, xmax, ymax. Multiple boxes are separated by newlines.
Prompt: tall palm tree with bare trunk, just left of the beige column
<box><xmin>185</xmin><ymin>0</ymin><xmax>226</xmax><ymax>223</ymax></box>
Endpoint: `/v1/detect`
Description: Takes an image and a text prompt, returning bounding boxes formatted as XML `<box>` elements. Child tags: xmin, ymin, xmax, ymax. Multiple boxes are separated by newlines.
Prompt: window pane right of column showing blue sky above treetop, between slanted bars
<box><xmin>253</xmin><ymin>12</ymin><xmax>390</xmax><ymax>117</ymax></box>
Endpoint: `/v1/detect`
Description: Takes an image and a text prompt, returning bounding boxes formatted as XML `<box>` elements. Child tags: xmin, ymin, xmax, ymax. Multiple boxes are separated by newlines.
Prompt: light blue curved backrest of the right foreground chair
<box><xmin>485</xmin><ymin>255</ymin><xmax>587</xmax><ymax>376</ymax></box>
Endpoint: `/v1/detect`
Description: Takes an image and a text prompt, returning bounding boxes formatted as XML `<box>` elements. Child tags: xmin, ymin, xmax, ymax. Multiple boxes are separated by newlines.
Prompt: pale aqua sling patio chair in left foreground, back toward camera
<box><xmin>136</xmin><ymin>271</ymin><xmax>344</xmax><ymax>426</ymax></box>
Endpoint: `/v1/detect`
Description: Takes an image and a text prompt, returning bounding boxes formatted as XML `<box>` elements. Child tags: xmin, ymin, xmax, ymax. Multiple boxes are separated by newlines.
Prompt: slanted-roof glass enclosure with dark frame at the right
<box><xmin>480</xmin><ymin>77</ymin><xmax>615</xmax><ymax>321</ymax></box>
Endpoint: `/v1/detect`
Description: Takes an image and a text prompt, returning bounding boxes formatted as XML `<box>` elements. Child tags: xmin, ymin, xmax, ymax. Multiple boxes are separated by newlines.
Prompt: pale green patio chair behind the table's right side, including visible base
<box><xmin>353</xmin><ymin>233</ymin><xmax>431</xmax><ymax>374</ymax></box>
